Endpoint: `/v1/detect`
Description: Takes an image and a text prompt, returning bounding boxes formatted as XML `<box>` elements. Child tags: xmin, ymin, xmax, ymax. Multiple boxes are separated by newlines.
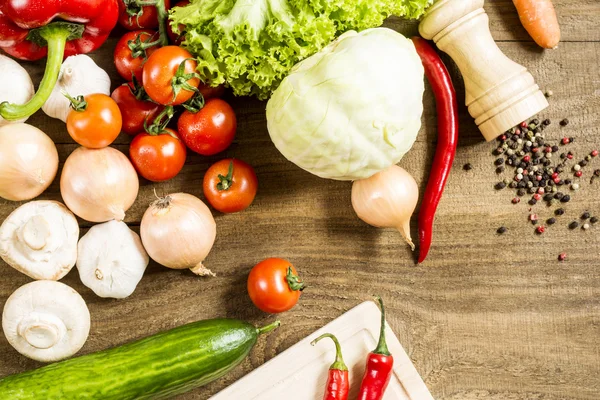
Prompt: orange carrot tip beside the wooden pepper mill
<box><xmin>513</xmin><ymin>0</ymin><xmax>560</xmax><ymax>49</ymax></box>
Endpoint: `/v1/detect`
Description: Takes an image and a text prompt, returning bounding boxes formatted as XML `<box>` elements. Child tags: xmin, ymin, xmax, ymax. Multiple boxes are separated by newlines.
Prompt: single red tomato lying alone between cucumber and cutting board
<box><xmin>248</xmin><ymin>258</ymin><xmax>304</xmax><ymax>314</ymax></box>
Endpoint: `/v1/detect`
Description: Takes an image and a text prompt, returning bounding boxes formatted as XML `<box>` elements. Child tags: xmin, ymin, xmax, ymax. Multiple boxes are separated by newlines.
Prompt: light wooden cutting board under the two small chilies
<box><xmin>211</xmin><ymin>301</ymin><xmax>433</xmax><ymax>400</ymax></box>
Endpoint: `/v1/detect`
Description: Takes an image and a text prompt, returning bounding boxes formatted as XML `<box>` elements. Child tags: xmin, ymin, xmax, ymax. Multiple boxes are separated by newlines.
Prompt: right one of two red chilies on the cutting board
<box><xmin>358</xmin><ymin>297</ymin><xmax>394</xmax><ymax>400</ymax></box>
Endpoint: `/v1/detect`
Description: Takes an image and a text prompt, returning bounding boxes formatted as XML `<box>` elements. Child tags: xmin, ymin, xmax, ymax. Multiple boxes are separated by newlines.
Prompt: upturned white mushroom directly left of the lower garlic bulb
<box><xmin>0</xmin><ymin>200</ymin><xmax>79</xmax><ymax>280</ymax></box>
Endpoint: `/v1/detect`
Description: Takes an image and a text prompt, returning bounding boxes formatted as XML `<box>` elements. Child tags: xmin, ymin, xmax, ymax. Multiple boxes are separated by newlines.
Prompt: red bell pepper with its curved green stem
<box><xmin>0</xmin><ymin>0</ymin><xmax>119</xmax><ymax>120</ymax></box>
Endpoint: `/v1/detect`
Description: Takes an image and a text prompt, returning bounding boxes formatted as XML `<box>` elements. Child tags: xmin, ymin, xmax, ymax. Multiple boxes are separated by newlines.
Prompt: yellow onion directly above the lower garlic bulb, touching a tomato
<box><xmin>60</xmin><ymin>147</ymin><xmax>140</xmax><ymax>222</ymax></box>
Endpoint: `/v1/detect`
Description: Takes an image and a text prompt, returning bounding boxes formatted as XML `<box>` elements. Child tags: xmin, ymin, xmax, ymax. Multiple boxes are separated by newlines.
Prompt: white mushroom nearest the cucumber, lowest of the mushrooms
<box><xmin>2</xmin><ymin>281</ymin><xmax>90</xmax><ymax>362</ymax></box>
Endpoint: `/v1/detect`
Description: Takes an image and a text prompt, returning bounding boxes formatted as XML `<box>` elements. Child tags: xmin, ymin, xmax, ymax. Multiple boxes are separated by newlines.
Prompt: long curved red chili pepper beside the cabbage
<box><xmin>412</xmin><ymin>37</ymin><xmax>458</xmax><ymax>263</ymax></box>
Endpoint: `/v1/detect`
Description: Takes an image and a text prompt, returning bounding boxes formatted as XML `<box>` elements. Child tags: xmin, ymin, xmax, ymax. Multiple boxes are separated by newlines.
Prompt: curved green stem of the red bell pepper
<box><xmin>0</xmin><ymin>24</ymin><xmax>73</xmax><ymax>121</ymax></box>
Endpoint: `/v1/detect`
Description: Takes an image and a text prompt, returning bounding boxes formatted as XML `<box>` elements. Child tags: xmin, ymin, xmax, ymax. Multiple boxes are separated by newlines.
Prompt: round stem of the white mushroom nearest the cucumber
<box><xmin>17</xmin><ymin>313</ymin><xmax>67</xmax><ymax>349</ymax></box>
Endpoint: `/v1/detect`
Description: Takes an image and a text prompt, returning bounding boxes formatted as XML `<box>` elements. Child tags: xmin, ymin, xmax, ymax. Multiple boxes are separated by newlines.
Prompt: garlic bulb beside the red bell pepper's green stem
<box><xmin>42</xmin><ymin>54</ymin><xmax>110</xmax><ymax>122</ymax></box>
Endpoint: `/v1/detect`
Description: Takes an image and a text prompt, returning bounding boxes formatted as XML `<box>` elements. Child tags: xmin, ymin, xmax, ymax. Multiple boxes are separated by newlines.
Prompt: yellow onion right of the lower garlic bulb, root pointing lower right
<box><xmin>140</xmin><ymin>193</ymin><xmax>217</xmax><ymax>276</ymax></box>
